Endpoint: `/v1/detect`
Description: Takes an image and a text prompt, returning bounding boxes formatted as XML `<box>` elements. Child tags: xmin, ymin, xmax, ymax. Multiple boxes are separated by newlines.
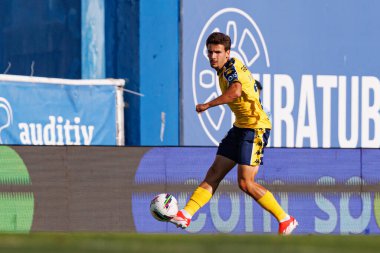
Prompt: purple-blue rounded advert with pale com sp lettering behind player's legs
<box><xmin>132</xmin><ymin>147</ymin><xmax>380</xmax><ymax>234</ymax></box>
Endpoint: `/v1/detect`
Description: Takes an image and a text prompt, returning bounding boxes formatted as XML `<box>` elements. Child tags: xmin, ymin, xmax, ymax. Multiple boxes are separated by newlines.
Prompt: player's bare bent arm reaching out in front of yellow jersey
<box><xmin>195</xmin><ymin>81</ymin><xmax>242</xmax><ymax>112</ymax></box>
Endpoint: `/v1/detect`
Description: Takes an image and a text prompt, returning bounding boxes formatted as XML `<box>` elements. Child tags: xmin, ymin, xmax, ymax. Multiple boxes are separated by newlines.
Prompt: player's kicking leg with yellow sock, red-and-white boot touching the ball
<box><xmin>170</xmin><ymin>155</ymin><xmax>236</xmax><ymax>228</ymax></box>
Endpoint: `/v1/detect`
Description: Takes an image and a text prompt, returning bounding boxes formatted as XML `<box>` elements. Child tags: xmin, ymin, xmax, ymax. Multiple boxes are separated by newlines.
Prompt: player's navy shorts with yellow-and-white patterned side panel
<box><xmin>217</xmin><ymin>126</ymin><xmax>270</xmax><ymax>166</ymax></box>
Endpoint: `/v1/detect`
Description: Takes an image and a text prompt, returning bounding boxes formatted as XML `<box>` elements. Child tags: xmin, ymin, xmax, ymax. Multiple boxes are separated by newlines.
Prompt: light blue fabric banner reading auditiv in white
<box><xmin>0</xmin><ymin>75</ymin><xmax>123</xmax><ymax>145</ymax></box>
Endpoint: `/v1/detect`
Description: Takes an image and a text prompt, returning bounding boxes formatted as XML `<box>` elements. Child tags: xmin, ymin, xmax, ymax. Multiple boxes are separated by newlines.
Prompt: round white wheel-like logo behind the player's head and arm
<box><xmin>192</xmin><ymin>8</ymin><xmax>270</xmax><ymax>145</ymax></box>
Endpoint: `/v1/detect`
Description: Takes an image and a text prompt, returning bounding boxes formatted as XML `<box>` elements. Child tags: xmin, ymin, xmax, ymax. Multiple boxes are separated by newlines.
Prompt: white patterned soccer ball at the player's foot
<box><xmin>150</xmin><ymin>193</ymin><xmax>178</xmax><ymax>221</ymax></box>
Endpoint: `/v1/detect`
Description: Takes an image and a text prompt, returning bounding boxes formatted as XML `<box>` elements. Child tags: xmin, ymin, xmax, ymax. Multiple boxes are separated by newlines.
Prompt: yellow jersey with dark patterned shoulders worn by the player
<box><xmin>218</xmin><ymin>58</ymin><xmax>272</xmax><ymax>129</ymax></box>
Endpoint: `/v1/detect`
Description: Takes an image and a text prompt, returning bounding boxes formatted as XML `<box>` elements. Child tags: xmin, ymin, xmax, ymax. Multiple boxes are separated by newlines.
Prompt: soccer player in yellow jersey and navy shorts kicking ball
<box><xmin>170</xmin><ymin>32</ymin><xmax>298</xmax><ymax>235</ymax></box>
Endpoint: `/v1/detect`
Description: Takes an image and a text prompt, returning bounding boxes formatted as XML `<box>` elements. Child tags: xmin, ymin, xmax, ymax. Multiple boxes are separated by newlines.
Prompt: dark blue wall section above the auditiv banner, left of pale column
<box><xmin>0</xmin><ymin>0</ymin><xmax>81</xmax><ymax>78</ymax></box>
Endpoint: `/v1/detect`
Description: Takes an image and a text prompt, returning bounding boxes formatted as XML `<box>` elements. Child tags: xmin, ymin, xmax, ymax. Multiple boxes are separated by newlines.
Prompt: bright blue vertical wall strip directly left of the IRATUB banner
<box><xmin>140</xmin><ymin>0</ymin><xmax>179</xmax><ymax>145</ymax></box>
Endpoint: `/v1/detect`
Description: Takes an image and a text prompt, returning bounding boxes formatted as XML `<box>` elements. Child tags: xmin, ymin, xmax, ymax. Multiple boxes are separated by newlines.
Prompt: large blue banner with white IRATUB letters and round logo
<box><xmin>181</xmin><ymin>0</ymin><xmax>380</xmax><ymax>148</ymax></box>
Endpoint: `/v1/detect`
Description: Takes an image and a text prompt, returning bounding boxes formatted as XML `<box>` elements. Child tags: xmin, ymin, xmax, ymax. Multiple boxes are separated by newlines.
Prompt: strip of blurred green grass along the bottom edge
<box><xmin>0</xmin><ymin>233</ymin><xmax>380</xmax><ymax>253</ymax></box>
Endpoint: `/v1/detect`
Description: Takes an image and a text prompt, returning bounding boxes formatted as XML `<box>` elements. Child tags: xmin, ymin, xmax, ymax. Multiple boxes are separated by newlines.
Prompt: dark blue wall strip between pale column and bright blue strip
<box><xmin>105</xmin><ymin>0</ymin><xmax>140</xmax><ymax>145</ymax></box>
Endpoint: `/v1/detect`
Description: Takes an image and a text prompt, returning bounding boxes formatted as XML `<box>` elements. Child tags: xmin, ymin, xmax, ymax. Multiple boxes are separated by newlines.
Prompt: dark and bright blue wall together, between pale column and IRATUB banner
<box><xmin>105</xmin><ymin>0</ymin><xmax>179</xmax><ymax>146</ymax></box>
